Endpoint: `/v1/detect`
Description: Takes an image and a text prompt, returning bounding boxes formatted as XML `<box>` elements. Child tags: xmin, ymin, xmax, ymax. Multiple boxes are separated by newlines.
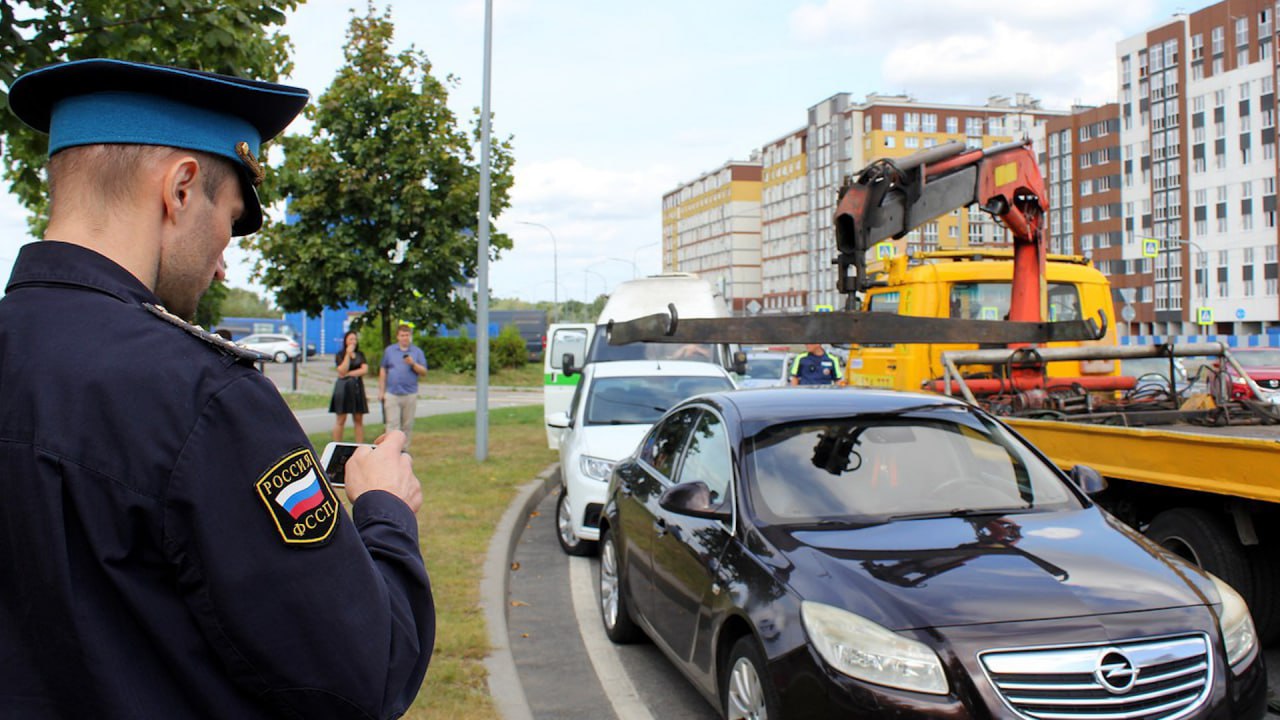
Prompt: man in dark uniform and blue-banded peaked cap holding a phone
<box><xmin>0</xmin><ymin>60</ymin><xmax>435</xmax><ymax>720</ymax></box>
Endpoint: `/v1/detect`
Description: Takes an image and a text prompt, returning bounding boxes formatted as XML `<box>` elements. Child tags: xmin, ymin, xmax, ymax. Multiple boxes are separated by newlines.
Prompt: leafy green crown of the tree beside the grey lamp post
<box><xmin>242</xmin><ymin>5</ymin><xmax>512</xmax><ymax>345</ymax></box>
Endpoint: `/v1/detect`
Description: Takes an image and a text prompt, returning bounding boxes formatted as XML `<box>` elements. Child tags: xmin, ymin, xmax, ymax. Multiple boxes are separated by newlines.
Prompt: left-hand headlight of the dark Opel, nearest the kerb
<box><xmin>800</xmin><ymin>601</ymin><xmax>948</xmax><ymax>694</ymax></box>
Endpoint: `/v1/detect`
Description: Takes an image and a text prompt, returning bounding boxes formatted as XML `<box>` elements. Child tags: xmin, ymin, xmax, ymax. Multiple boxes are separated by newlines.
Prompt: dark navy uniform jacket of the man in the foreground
<box><xmin>0</xmin><ymin>241</ymin><xmax>435</xmax><ymax>720</ymax></box>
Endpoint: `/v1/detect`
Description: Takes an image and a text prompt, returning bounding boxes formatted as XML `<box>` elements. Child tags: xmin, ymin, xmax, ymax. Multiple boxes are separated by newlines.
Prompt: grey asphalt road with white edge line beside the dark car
<box><xmin>507</xmin><ymin>477</ymin><xmax>1280</xmax><ymax>720</ymax></box>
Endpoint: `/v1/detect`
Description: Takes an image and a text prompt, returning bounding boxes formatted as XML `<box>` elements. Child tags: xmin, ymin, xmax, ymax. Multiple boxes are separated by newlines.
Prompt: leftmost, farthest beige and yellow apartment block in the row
<box><xmin>662</xmin><ymin>159</ymin><xmax>762</xmax><ymax>313</ymax></box>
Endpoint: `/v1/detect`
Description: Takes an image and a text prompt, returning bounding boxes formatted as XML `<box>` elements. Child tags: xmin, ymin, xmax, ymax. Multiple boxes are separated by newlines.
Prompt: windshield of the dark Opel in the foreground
<box><xmin>748</xmin><ymin>409</ymin><xmax>1082</xmax><ymax>525</ymax></box>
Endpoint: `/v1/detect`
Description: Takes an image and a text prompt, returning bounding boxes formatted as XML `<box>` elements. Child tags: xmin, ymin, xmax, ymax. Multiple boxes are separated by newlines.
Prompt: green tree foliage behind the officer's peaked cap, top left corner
<box><xmin>0</xmin><ymin>0</ymin><xmax>300</xmax><ymax>229</ymax></box>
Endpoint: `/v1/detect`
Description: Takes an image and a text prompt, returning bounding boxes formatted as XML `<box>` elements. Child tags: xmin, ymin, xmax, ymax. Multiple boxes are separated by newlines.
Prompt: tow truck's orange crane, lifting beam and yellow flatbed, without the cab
<box><xmin>608</xmin><ymin>141</ymin><xmax>1280</xmax><ymax>642</ymax></box>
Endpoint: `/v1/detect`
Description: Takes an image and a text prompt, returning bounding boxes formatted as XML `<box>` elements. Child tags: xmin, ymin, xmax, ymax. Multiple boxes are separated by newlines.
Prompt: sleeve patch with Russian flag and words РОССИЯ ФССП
<box><xmin>253</xmin><ymin>447</ymin><xmax>339</xmax><ymax>546</ymax></box>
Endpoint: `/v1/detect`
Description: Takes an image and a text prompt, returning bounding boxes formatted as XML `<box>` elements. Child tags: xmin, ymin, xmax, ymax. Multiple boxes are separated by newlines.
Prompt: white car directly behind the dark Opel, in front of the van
<box><xmin>547</xmin><ymin>360</ymin><xmax>735</xmax><ymax>555</ymax></box>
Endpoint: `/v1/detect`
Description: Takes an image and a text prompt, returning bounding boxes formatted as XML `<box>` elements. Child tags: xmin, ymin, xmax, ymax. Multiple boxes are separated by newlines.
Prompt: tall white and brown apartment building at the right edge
<box><xmin>1110</xmin><ymin>0</ymin><xmax>1280</xmax><ymax>336</ymax></box>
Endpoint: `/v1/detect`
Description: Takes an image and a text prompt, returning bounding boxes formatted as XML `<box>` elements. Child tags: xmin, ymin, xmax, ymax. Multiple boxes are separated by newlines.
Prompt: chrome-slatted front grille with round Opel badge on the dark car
<box><xmin>978</xmin><ymin>634</ymin><xmax>1213</xmax><ymax>720</ymax></box>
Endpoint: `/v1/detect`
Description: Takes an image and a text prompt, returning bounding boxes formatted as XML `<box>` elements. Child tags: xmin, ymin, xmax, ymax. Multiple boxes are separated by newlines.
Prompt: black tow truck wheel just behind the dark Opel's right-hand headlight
<box><xmin>1147</xmin><ymin>507</ymin><xmax>1254</xmax><ymax>609</ymax></box>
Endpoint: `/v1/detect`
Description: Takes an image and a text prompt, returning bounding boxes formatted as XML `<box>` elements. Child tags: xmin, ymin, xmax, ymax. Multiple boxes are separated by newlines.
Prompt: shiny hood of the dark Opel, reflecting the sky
<box><xmin>767</xmin><ymin>509</ymin><xmax>1216</xmax><ymax>630</ymax></box>
